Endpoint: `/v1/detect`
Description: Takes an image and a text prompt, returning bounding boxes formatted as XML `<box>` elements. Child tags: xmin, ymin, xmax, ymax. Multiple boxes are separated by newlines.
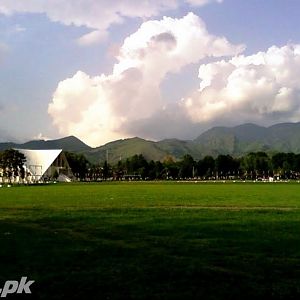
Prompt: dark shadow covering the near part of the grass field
<box><xmin>0</xmin><ymin>209</ymin><xmax>300</xmax><ymax>299</ymax></box>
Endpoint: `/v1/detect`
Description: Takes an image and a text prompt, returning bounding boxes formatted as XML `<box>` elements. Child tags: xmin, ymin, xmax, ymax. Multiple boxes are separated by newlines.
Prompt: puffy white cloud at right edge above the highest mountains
<box><xmin>182</xmin><ymin>45</ymin><xmax>300</xmax><ymax>124</ymax></box>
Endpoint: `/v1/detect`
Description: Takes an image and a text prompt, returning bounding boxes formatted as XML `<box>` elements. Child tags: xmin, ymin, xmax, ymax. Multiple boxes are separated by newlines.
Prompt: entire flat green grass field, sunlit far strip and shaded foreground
<box><xmin>0</xmin><ymin>182</ymin><xmax>300</xmax><ymax>299</ymax></box>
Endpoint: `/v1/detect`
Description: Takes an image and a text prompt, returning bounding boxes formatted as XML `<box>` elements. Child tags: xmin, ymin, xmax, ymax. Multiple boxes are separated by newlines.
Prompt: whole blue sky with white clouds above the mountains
<box><xmin>0</xmin><ymin>0</ymin><xmax>300</xmax><ymax>147</ymax></box>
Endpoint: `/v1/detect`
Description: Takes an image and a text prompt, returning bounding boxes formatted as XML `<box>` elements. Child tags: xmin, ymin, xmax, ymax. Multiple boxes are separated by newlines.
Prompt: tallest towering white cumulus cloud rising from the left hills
<box><xmin>48</xmin><ymin>13</ymin><xmax>244</xmax><ymax>145</ymax></box>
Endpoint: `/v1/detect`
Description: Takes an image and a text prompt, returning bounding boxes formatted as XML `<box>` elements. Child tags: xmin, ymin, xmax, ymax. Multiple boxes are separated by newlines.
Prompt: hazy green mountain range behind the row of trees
<box><xmin>0</xmin><ymin>123</ymin><xmax>300</xmax><ymax>164</ymax></box>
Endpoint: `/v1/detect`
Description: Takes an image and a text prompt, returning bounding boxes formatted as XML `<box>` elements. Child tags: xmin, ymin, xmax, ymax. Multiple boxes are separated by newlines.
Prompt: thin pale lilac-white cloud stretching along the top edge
<box><xmin>0</xmin><ymin>0</ymin><xmax>220</xmax><ymax>45</ymax></box>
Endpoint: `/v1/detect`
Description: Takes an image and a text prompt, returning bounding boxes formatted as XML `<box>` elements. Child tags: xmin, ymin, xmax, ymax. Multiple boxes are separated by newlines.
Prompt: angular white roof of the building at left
<box><xmin>16</xmin><ymin>149</ymin><xmax>62</xmax><ymax>176</ymax></box>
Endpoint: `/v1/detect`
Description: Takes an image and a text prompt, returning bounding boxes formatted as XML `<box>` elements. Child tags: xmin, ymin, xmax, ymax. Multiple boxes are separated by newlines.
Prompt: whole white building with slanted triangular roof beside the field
<box><xmin>17</xmin><ymin>149</ymin><xmax>73</xmax><ymax>182</ymax></box>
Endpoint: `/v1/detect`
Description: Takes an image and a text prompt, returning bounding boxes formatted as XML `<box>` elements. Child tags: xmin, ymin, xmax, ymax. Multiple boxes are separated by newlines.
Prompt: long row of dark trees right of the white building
<box><xmin>66</xmin><ymin>152</ymin><xmax>300</xmax><ymax>181</ymax></box>
